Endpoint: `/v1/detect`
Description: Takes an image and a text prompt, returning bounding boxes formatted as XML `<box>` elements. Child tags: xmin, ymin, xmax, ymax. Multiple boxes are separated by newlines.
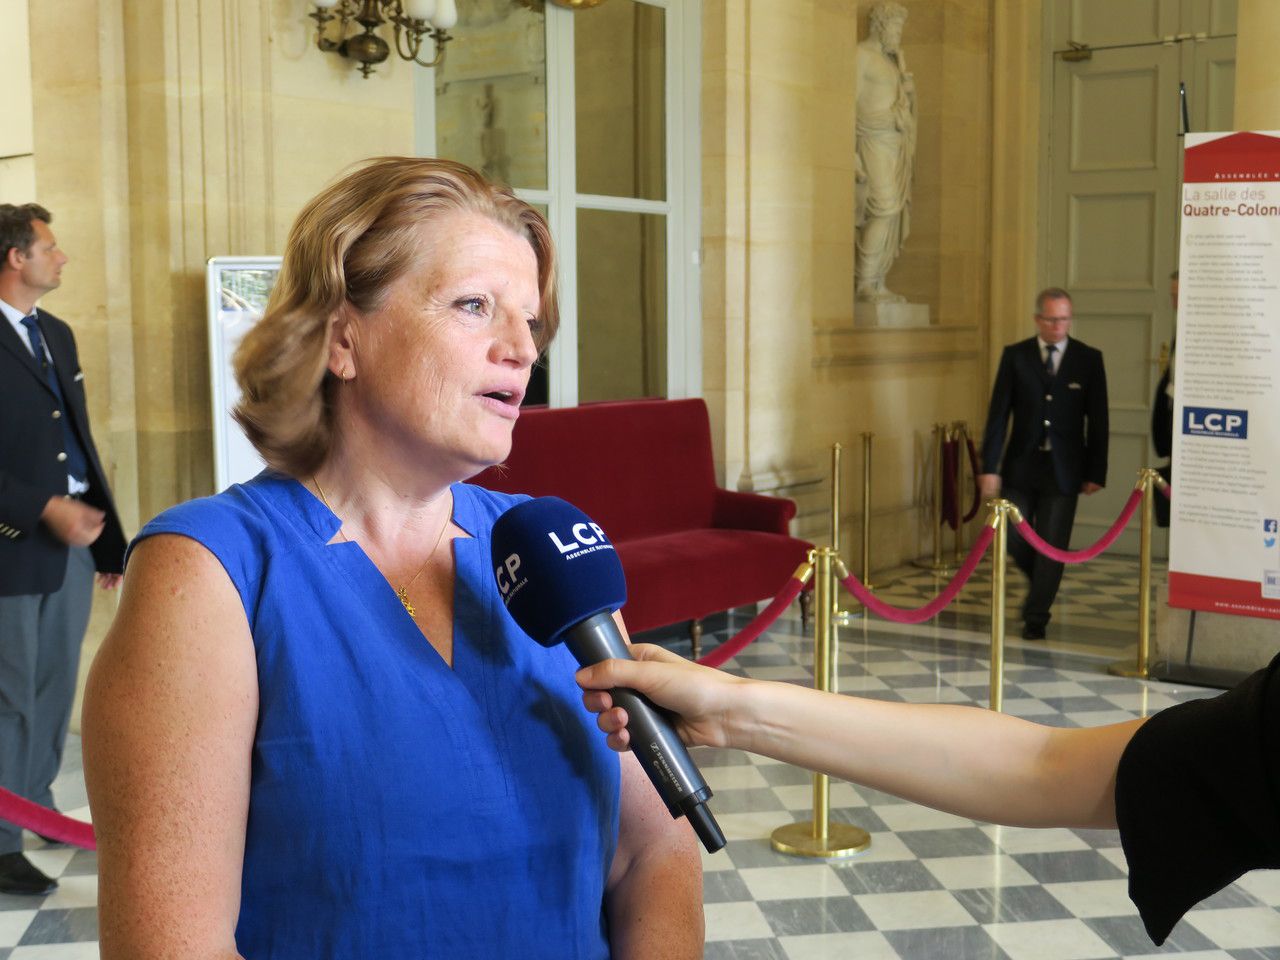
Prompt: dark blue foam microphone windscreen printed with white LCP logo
<box><xmin>492</xmin><ymin>497</ymin><xmax>627</xmax><ymax>646</ymax></box>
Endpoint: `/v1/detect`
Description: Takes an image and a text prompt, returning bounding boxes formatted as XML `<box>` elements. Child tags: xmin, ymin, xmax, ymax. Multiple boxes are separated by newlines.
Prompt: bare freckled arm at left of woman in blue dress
<box><xmin>83</xmin><ymin>535</ymin><xmax>257</xmax><ymax>960</ymax></box>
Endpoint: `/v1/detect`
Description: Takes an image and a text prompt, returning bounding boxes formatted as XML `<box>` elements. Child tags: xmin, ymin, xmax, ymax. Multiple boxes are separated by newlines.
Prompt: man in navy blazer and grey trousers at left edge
<box><xmin>0</xmin><ymin>204</ymin><xmax>125</xmax><ymax>895</ymax></box>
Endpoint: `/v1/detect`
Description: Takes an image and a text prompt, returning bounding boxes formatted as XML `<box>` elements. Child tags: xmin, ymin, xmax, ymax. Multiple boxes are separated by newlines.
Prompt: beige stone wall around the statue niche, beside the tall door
<box><xmin>703</xmin><ymin>0</ymin><xmax>998</xmax><ymax>567</ymax></box>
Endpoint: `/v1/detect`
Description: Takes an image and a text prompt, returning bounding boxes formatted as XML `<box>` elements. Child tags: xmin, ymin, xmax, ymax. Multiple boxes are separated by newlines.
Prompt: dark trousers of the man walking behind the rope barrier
<box><xmin>1004</xmin><ymin>451</ymin><xmax>1079</xmax><ymax>627</ymax></box>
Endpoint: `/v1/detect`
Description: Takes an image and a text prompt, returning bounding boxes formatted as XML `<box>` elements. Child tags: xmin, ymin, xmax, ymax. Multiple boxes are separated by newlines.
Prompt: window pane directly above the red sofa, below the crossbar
<box><xmin>577</xmin><ymin>210</ymin><xmax>667</xmax><ymax>403</ymax></box>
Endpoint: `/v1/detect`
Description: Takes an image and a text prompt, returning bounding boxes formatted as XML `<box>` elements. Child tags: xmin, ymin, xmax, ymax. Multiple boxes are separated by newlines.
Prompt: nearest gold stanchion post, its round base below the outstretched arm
<box><xmin>771</xmin><ymin>547</ymin><xmax>872</xmax><ymax>859</ymax></box>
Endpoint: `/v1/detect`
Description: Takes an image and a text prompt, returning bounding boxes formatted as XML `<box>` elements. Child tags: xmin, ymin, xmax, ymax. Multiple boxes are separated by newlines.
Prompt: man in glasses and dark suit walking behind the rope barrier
<box><xmin>978</xmin><ymin>287</ymin><xmax>1107</xmax><ymax>640</ymax></box>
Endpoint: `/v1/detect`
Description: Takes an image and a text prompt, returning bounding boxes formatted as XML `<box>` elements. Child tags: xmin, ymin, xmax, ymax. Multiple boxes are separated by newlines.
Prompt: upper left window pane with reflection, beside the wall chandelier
<box><xmin>435</xmin><ymin>0</ymin><xmax>547</xmax><ymax>189</ymax></box>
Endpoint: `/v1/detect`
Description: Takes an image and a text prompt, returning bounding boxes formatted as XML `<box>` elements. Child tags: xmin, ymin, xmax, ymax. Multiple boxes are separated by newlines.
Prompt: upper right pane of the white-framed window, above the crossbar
<box><xmin>573</xmin><ymin>0</ymin><xmax>667</xmax><ymax>200</ymax></box>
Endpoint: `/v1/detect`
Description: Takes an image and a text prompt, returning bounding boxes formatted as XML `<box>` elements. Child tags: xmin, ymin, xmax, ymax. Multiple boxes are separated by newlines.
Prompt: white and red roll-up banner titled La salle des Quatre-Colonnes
<box><xmin>1169</xmin><ymin>132</ymin><xmax>1280</xmax><ymax>620</ymax></box>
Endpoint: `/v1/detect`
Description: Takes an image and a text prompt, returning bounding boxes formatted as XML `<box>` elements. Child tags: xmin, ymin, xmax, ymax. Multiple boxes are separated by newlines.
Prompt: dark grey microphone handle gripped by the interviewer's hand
<box><xmin>564</xmin><ymin>613</ymin><xmax>724</xmax><ymax>854</ymax></box>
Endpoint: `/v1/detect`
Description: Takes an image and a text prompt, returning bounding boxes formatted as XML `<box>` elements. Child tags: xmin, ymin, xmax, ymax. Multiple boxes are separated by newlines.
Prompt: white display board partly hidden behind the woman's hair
<box><xmin>205</xmin><ymin>257</ymin><xmax>280</xmax><ymax>493</ymax></box>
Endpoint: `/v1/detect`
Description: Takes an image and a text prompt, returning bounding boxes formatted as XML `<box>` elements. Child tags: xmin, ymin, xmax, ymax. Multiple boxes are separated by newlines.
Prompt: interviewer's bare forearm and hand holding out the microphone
<box><xmin>579</xmin><ymin>644</ymin><xmax>1142</xmax><ymax>827</ymax></box>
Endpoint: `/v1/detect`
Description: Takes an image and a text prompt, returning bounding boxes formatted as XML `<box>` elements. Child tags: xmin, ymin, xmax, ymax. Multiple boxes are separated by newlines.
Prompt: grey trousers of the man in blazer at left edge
<box><xmin>0</xmin><ymin>547</ymin><xmax>93</xmax><ymax>854</ymax></box>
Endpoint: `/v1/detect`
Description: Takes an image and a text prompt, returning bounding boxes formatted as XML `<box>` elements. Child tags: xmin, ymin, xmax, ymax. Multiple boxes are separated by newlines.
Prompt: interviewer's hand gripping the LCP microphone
<box><xmin>577</xmin><ymin>644</ymin><xmax>751</xmax><ymax>751</ymax></box>
